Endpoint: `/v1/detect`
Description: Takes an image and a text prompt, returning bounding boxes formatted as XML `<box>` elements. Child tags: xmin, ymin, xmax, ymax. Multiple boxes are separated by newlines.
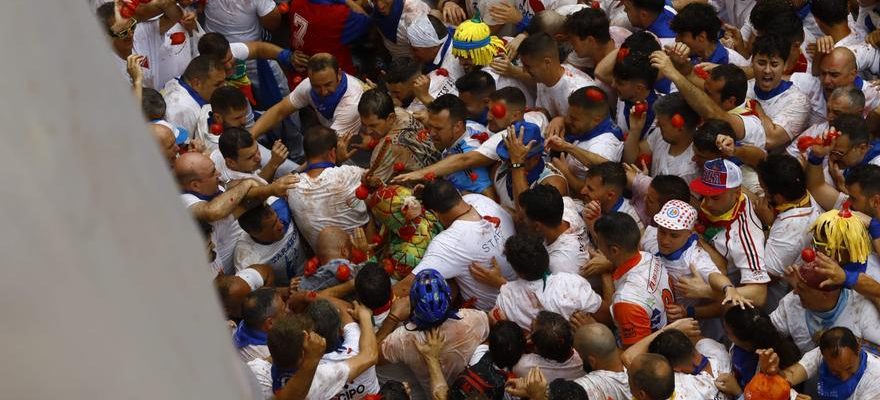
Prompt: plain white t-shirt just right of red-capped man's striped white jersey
<box><xmin>764</xmin><ymin>197</ymin><xmax>821</xmax><ymax>277</ymax></box>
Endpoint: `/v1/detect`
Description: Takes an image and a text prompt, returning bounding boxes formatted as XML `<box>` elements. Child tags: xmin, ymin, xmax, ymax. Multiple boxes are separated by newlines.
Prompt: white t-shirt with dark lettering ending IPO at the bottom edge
<box><xmin>320</xmin><ymin>322</ymin><xmax>379</xmax><ymax>399</ymax></box>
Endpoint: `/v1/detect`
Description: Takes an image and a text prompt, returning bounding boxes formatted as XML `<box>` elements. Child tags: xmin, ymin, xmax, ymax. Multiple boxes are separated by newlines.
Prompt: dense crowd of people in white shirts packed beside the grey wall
<box><xmin>89</xmin><ymin>0</ymin><xmax>880</xmax><ymax>400</ymax></box>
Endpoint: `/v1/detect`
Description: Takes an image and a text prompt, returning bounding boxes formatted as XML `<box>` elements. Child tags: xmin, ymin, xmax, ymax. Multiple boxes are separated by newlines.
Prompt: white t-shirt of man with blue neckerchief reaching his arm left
<box><xmin>287</xmin><ymin>74</ymin><xmax>364</xmax><ymax>136</ymax></box>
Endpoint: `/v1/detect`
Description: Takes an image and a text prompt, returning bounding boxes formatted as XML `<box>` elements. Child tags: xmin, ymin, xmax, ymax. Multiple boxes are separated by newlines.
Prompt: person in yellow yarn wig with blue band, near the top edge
<box><xmin>452</xmin><ymin>18</ymin><xmax>535</xmax><ymax>107</ymax></box>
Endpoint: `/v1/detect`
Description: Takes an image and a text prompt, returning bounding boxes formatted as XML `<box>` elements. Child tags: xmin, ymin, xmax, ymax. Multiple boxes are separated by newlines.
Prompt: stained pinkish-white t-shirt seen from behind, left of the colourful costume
<box><xmin>287</xmin><ymin>165</ymin><xmax>370</xmax><ymax>248</ymax></box>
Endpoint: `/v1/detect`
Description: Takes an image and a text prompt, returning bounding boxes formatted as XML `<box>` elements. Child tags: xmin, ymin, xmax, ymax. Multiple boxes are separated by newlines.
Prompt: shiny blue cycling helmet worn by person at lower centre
<box><xmin>409</xmin><ymin>269</ymin><xmax>458</xmax><ymax>330</ymax></box>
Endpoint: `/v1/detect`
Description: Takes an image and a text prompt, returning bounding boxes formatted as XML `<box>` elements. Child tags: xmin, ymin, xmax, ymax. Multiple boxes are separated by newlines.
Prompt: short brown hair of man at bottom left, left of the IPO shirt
<box><xmin>268</xmin><ymin>316</ymin><xmax>312</xmax><ymax>368</ymax></box>
